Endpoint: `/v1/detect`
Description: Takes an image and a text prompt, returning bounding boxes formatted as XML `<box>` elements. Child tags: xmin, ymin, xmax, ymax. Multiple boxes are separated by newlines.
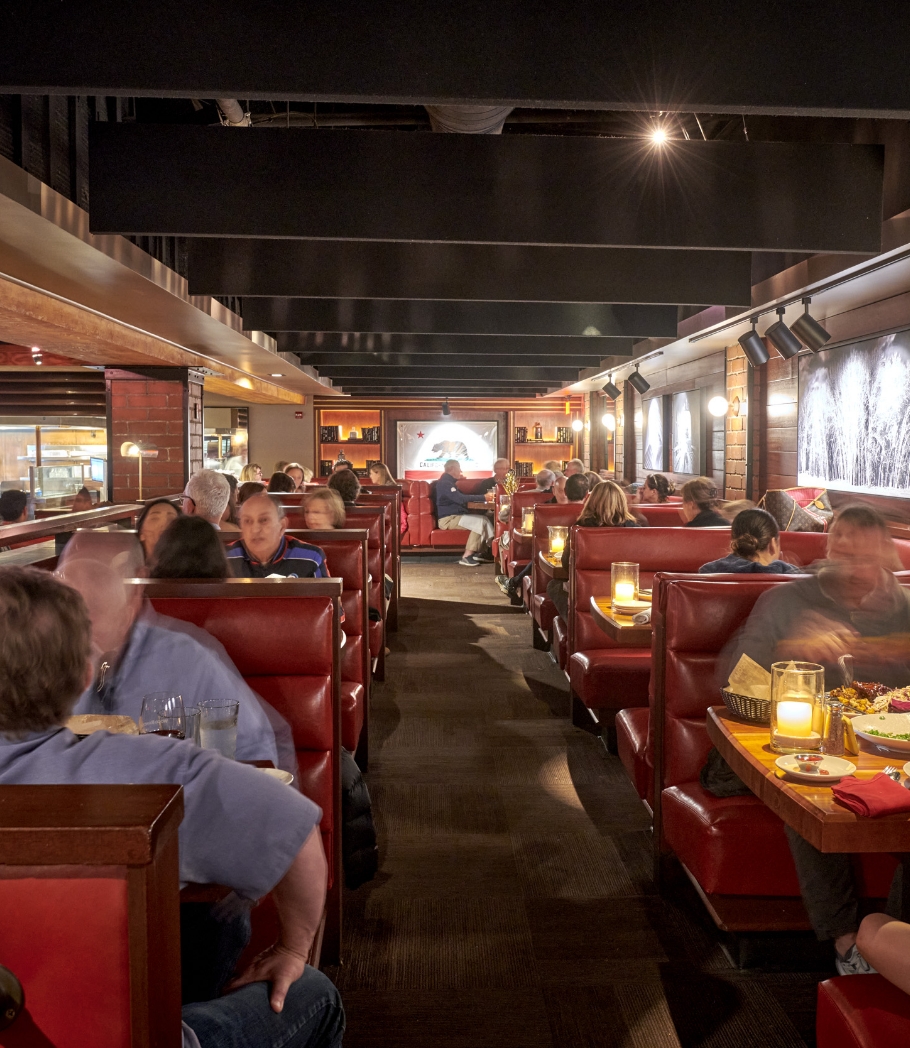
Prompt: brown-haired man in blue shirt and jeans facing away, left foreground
<box><xmin>0</xmin><ymin>567</ymin><xmax>344</xmax><ymax>1048</ymax></box>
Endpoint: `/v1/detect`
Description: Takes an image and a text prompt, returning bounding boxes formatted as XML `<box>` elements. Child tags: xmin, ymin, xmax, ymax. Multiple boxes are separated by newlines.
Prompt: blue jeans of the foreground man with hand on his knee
<box><xmin>183</xmin><ymin>965</ymin><xmax>345</xmax><ymax>1048</ymax></box>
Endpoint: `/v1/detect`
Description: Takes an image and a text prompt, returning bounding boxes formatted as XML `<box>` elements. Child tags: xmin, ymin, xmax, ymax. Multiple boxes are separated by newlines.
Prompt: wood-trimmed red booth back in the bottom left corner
<box><xmin>0</xmin><ymin>785</ymin><xmax>183</xmax><ymax>1048</ymax></box>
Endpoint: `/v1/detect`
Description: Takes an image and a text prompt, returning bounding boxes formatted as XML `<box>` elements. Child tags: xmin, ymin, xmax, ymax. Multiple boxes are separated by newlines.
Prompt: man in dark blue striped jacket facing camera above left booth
<box><xmin>228</xmin><ymin>495</ymin><xmax>329</xmax><ymax>578</ymax></box>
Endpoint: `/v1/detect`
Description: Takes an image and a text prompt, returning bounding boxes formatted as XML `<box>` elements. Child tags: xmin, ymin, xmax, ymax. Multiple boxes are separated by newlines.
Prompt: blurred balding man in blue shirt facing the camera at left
<box><xmin>55</xmin><ymin>533</ymin><xmax>278</xmax><ymax>764</ymax></box>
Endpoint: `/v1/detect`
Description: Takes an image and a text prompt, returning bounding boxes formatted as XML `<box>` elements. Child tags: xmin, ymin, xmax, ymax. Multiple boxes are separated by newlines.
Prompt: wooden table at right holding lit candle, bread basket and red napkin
<box><xmin>708</xmin><ymin>706</ymin><xmax>910</xmax><ymax>855</ymax></box>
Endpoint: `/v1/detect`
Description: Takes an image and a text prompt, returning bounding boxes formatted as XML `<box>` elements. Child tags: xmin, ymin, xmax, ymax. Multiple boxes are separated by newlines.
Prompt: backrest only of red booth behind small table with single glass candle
<box><xmin>567</xmin><ymin>525</ymin><xmax>730</xmax><ymax>654</ymax></box>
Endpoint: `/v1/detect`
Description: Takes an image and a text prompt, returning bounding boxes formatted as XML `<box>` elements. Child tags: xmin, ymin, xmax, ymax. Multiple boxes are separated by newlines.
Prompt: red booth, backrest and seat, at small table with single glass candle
<box><xmin>570</xmin><ymin>526</ymin><xmax>730</xmax><ymax>728</ymax></box>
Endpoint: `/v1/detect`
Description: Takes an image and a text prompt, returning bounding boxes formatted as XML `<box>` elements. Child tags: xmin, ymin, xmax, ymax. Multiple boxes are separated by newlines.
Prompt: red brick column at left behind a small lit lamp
<box><xmin>105</xmin><ymin>368</ymin><xmax>202</xmax><ymax>502</ymax></box>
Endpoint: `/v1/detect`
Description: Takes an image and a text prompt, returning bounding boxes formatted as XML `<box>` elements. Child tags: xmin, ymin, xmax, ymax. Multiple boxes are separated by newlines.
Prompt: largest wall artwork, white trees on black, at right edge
<box><xmin>797</xmin><ymin>331</ymin><xmax>910</xmax><ymax>498</ymax></box>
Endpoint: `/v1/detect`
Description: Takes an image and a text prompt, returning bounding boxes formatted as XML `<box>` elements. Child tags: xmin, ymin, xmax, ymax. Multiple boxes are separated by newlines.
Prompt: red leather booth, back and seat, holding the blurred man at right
<box><xmin>638</xmin><ymin>573</ymin><xmax>895</xmax><ymax>932</ymax></box>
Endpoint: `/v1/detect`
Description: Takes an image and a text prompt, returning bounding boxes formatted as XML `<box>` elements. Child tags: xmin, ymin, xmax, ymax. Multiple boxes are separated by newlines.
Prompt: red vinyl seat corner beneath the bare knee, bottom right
<box><xmin>816</xmin><ymin>975</ymin><xmax>910</xmax><ymax>1048</ymax></box>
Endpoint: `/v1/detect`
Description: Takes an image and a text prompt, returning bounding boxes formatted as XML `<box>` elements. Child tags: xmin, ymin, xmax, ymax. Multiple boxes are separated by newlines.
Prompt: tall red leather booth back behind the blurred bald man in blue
<box><xmin>130</xmin><ymin>578</ymin><xmax>342</xmax><ymax>963</ymax></box>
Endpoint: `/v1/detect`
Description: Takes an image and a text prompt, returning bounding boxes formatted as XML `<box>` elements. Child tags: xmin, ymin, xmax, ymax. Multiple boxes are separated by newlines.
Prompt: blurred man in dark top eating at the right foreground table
<box><xmin>722</xmin><ymin>506</ymin><xmax>910</xmax><ymax>975</ymax></box>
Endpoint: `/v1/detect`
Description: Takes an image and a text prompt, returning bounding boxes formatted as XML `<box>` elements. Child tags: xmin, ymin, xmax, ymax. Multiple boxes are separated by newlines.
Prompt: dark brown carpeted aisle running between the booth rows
<box><xmin>328</xmin><ymin>559</ymin><xmax>822</xmax><ymax>1048</ymax></box>
